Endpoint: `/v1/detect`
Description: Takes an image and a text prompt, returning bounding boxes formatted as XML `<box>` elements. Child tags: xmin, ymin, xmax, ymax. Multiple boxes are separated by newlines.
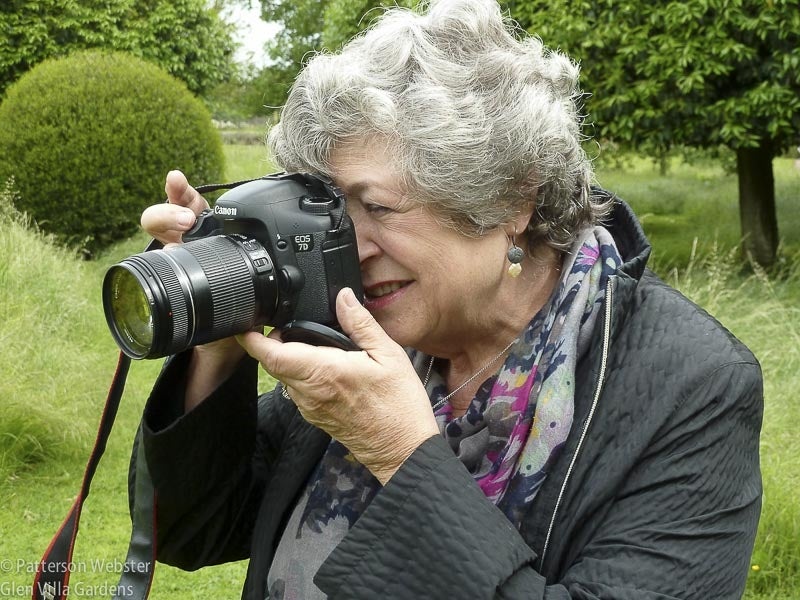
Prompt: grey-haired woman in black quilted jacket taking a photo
<box><xmin>136</xmin><ymin>0</ymin><xmax>762</xmax><ymax>600</ymax></box>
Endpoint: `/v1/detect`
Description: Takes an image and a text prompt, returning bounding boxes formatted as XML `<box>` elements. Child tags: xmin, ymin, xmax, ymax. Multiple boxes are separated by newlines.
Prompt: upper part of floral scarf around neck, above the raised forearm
<box><xmin>429</xmin><ymin>227</ymin><xmax>622</xmax><ymax>527</ymax></box>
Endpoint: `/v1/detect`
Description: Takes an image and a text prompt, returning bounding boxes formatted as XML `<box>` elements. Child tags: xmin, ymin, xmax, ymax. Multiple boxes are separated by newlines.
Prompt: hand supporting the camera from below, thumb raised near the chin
<box><xmin>238</xmin><ymin>288</ymin><xmax>439</xmax><ymax>484</ymax></box>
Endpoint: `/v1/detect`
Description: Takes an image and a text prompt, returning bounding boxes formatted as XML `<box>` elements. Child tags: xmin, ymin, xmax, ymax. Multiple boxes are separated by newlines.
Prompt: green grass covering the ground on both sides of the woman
<box><xmin>0</xmin><ymin>146</ymin><xmax>800</xmax><ymax>600</ymax></box>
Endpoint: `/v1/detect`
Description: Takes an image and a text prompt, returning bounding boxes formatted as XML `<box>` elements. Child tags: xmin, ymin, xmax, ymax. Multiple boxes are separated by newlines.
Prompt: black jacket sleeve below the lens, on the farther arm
<box><xmin>134</xmin><ymin>355</ymin><xmax>278</xmax><ymax>570</ymax></box>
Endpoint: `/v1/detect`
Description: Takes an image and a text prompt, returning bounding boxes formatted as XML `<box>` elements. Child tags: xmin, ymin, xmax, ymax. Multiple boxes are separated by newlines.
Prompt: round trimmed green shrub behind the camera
<box><xmin>0</xmin><ymin>51</ymin><xmax>224</xmax><ymax>254</ymax></box>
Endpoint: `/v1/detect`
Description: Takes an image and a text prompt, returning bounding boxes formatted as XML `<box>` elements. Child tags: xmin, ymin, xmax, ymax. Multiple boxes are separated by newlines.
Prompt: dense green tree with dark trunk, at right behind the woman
<box><xmin>507</xmin><ymin>0</ymin><xmax>800</xmax><ymax>266</ymax></box>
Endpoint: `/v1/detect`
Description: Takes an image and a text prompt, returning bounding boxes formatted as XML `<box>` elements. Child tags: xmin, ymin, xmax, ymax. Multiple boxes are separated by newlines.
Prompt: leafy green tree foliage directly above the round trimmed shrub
<box><xmin>0</xmin><ymin>0</ymin><xmax>235</xmax><ymax>96</ymax></box>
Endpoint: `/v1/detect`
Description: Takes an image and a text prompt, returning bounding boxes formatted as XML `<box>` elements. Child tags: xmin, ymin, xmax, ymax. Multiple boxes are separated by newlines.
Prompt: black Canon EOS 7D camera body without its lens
<box><xmin>188</xmin><ymin>173</ymin><xmax>364</xmax><ymax>327</ymax></box>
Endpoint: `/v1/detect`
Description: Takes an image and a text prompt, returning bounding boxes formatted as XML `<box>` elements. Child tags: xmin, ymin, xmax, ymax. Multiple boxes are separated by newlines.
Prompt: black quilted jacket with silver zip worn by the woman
<box><xmin>138</xmin><ymin>202</ymin><xmax>762</xmax><ymax>600</ymax></box>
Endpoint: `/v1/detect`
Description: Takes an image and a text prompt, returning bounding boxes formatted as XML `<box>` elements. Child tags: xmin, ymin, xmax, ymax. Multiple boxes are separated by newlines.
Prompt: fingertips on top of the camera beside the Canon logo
<box><xmin>141</xmin><ymin>171</ymin><xmax>208</xmax><ymax>244</ymax></box>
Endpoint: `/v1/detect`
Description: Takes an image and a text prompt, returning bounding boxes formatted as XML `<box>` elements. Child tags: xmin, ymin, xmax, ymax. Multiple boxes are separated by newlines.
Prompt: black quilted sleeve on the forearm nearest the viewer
<box><xmin>314</xmin><ymin>436</ymin><xmax>544</xmax><ymax>600</ymax></box>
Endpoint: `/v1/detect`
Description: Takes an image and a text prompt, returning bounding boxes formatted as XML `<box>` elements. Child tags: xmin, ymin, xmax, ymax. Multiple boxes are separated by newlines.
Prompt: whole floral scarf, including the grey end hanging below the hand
<box><xmin>268</xmin><ymin>227</ymin><xmax>622</xmax><ymax>600</ymax></box>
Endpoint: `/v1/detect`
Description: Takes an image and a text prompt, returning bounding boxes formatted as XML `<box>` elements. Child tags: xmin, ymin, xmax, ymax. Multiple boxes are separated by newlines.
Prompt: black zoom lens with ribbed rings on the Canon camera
<box><xmin>103</xmin><ymin>235</ymin><xmax>278</xmax><ymax>359</ymax></box>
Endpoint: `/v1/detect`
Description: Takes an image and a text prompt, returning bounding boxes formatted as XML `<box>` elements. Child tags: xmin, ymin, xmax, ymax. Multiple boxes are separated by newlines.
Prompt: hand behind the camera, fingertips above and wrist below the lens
<box><xmin>141</xmin><ymin>171</ymin><xmax>245</xmax><ymax>412</ymax></box>
